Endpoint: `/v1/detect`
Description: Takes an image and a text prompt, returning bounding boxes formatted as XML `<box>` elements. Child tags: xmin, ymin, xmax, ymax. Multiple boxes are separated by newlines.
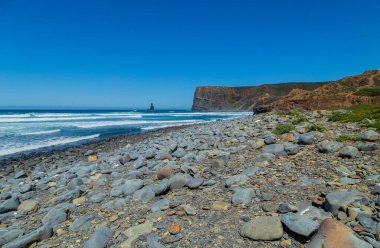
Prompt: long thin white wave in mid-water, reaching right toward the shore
<box><xmin>67</xmin><ymin>120</ymin><xmax>204</xmax><ymax>128</ymax></box>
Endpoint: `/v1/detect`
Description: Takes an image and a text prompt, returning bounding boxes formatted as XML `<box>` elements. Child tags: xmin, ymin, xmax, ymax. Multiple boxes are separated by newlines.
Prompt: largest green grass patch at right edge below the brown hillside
<box><xmin>329</xmin><ymin>105</ymin><xmax>380</xmax><ymax>130</ymax></box>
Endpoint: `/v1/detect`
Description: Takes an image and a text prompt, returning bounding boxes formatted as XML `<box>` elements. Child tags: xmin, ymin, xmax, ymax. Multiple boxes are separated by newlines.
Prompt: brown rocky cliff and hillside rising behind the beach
<box><xmin>192</xmin><ymin>70</ymin><xmax>380</xmax><ymax>112</ymax></box>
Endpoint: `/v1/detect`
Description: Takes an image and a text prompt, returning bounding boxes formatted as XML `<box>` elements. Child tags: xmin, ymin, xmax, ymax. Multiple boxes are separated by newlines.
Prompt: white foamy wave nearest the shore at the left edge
<box><xmin>0</xmin><ymin>134</ymin><xmax>99</xmax><ymax>156</ymax></box>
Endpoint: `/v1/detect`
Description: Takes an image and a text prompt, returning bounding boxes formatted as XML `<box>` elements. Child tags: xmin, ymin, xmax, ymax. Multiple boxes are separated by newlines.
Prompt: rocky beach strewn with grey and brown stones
<box><xmin>0</xmin><ymin>111</ymin><xmax>380</xmax><ymax>248</ymax></box>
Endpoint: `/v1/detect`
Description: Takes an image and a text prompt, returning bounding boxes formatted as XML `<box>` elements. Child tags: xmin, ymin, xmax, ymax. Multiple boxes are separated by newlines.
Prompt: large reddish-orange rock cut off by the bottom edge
<box><xmin>306</xmin><ymin>218</ymin><xmax>372</xmax><ymax>248</ymax></box>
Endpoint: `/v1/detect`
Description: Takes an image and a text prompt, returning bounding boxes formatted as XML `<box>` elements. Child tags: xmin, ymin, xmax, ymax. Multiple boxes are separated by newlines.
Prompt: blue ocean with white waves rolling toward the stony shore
<box><xmin>0</xmin><ymin>110</ymin><xmax>252</xmax><ymax>158</ymax></box>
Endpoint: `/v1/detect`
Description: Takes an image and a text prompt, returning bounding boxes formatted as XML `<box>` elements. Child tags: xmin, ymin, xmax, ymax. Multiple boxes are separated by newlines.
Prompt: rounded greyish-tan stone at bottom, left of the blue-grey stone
<box><xmin>241</xmin><ymin>216</ymin><xmax>283</xmax><ymax>241</ymax></box>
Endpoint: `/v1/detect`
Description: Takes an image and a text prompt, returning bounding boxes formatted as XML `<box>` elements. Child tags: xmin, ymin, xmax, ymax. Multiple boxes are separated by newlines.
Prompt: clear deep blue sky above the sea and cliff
<box><xmin>0</xmin><ymin>0</ymin><xmax>380</xmax><ymax>109</ymax></box>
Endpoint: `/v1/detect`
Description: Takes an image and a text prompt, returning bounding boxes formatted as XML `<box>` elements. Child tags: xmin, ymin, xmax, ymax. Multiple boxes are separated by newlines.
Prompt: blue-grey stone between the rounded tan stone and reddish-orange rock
<box><xmin>281</xmin><ymin>214</ymin><xmax>319</xmax><ymax>237</ymax></box>
